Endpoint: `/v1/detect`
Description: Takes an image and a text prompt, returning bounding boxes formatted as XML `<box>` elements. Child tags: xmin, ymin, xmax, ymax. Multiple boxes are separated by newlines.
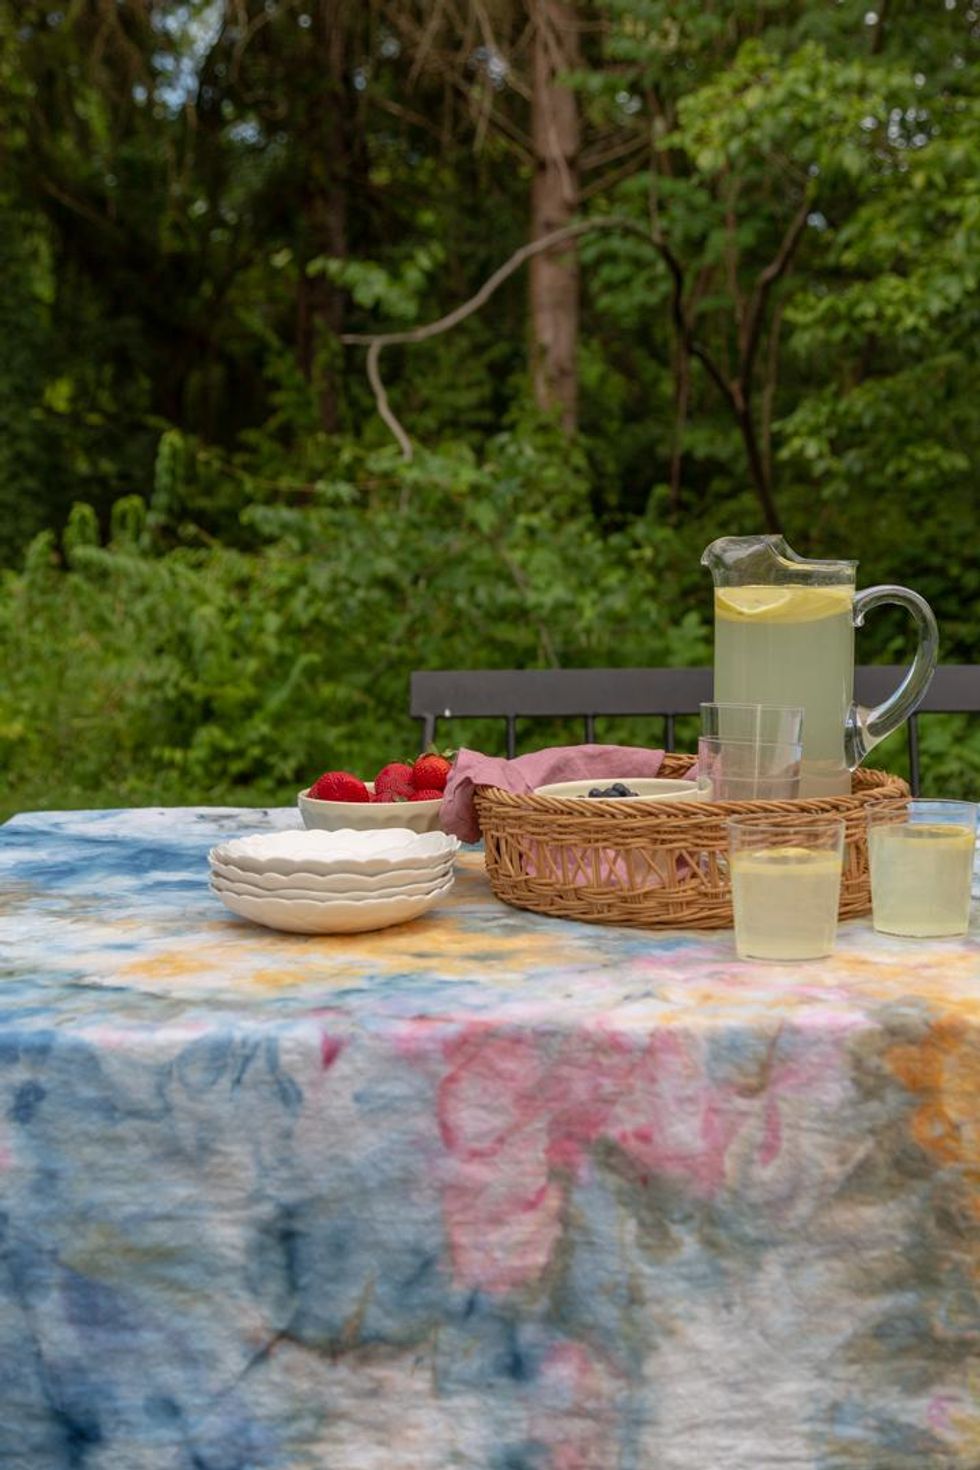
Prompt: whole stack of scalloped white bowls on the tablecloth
<box><xmin>207</xmin><ymin>828</ymin><xmax>460</xmax><ymax>933</ymax></box>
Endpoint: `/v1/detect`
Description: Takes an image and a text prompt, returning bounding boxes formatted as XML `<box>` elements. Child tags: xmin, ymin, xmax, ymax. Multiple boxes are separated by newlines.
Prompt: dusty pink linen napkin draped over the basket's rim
<box><xmin>439</xmin><ymin>745</ymin><xmax>678</xmax><ymax>842</ymax></box>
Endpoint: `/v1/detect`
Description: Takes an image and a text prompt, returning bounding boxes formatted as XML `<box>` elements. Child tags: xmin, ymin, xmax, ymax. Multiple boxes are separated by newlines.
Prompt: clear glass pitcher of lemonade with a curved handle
<box><xmin>701</xmin><ymin>537</ymin><xmax>939</xmax><ymax>797</ymax></box>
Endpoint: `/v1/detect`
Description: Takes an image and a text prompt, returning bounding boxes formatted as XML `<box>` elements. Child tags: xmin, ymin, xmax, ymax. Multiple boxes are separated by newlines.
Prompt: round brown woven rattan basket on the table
<box><xmin>476</xmin><ymin>754</ymin><xmax>908</xmax><ymax>929</ymax></box>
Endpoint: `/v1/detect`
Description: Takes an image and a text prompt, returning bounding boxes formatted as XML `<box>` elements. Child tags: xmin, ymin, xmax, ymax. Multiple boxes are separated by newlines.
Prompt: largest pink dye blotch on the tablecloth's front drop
<box><xmin>438</xmin><ymin>1023</ymin><xmax>840</xmax><ymax>1291</ymax></box>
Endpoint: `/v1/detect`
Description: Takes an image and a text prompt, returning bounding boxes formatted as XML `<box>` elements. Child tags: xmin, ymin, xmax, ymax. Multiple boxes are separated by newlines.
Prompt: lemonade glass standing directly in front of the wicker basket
<box><xmin>727</xmin><ymin>817</ymin><xmax>843</xmax><ymax>960</ymax></box>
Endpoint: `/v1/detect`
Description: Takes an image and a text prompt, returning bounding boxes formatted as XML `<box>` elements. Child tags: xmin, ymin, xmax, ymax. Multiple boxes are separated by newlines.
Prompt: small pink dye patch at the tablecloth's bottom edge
<box><xmin>527</xmin><ymin>1342</ymin><xmax>617</xmax><ymax>1470</ymax></box>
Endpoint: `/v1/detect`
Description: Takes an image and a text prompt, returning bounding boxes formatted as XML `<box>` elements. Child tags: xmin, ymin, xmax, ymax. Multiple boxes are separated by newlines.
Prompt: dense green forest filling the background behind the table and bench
<box><xmin>0</xmin><ymin>0</ymin><xmax>980</xmax><ymax>814</ymax></box>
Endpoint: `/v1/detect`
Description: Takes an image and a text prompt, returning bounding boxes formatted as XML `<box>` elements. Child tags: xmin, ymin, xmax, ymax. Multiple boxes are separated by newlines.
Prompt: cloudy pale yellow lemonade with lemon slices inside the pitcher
<box><xmin>714</xmin><ymin>587</ymin><xmax>854</xmax><ymax>795</ymax></box>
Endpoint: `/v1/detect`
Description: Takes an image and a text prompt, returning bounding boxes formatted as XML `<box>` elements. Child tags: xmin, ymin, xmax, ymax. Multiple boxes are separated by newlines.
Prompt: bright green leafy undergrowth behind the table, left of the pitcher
<box><xmin>0</xmin><ymin>435</ymin><xmax>708</xmax><ymax>801</ymax></box>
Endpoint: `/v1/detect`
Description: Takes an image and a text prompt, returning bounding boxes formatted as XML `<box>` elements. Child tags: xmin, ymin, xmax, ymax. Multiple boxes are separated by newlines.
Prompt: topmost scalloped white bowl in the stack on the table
<box><xmin>207</xmin><ymin>828</ymin><xmax>460</xmax><ymax>878</ymax></box>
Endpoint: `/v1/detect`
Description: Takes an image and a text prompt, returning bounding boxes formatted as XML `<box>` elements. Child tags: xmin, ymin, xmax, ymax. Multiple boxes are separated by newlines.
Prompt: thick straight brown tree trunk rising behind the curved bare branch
<box><xmin>530</xmin><ymin>0</ymin><xmax>579</xmax><ymax>434</ymax></box>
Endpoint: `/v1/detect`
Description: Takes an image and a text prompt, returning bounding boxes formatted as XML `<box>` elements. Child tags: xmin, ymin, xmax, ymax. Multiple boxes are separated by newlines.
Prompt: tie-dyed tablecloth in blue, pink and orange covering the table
<box><xmin>0</xmin><ymin>810</ymin><xmax>980</xmax><ymax>1470</ymax></box>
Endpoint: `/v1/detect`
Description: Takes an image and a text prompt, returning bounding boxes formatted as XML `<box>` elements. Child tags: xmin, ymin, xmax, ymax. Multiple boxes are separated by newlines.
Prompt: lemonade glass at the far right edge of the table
<box><xmin>868</xmin><ymin>800</ymin><xmax>977</xmax><ymax>939</ymax></box>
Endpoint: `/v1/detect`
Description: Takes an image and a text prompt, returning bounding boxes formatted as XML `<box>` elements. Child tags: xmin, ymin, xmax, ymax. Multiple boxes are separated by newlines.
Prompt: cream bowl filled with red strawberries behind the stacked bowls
<box><xmin>297</xmin><ymin>751</ymin><xmax>453</xmax><ymax>832</ymax></box>
